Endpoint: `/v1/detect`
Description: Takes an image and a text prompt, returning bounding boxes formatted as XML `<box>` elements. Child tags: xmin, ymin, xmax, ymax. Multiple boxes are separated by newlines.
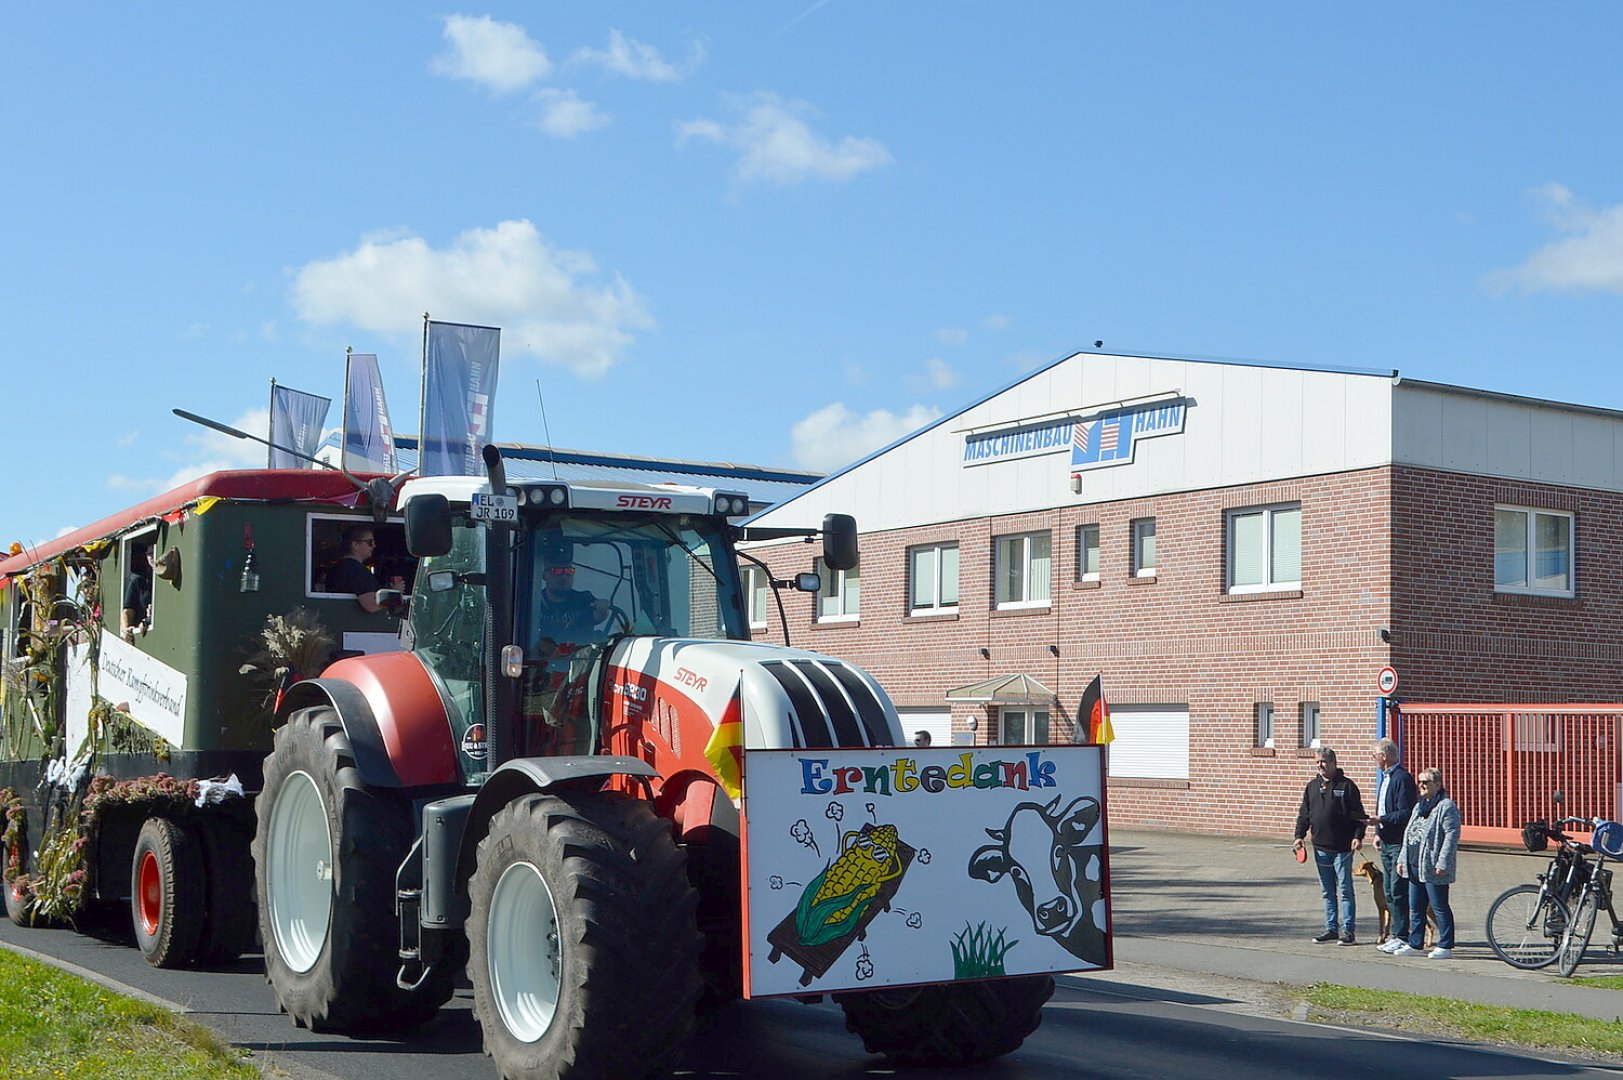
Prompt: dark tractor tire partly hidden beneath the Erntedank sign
<box><xmin>836</xmin><ymin>974</ymin><xmax>1053</xmax><ymax>1067</ymax></box>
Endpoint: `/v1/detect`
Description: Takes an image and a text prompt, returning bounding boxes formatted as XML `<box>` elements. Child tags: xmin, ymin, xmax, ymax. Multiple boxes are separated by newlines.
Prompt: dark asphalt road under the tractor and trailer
<box><xmin>0</xmin><ymin>919</ymin><xmax>1617</xmax><ymax>1080</ymax></box>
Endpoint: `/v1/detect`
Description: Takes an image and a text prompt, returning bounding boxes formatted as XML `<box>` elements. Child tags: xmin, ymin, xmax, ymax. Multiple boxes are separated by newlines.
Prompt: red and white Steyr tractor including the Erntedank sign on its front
<box><xmin>253</xmin><ymin>447</ymin><xmax>1112</xmax><ymax>1080</ymax></box>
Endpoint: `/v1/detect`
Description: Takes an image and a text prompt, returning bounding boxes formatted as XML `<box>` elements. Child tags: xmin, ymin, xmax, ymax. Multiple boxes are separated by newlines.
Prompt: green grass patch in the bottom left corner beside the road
<box><xmin>0</xmin><ymin>948</ymin><xmax>260</xmax><ymax>1080</ymax></box>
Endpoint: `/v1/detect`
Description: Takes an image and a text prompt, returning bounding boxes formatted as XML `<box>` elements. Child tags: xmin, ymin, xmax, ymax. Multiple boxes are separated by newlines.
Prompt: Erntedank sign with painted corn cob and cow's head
<box><xmin>743</xmin><ymin>745</ymin><xmax>1110</xmax><ymax>997</ymax></box>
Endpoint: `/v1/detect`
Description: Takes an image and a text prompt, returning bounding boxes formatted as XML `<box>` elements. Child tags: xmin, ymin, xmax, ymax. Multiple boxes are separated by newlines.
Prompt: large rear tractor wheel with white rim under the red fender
<box><xmin>253</xmin><ymin>708</ymin><xmax>456</xmax><ymax>1035</ymax></box>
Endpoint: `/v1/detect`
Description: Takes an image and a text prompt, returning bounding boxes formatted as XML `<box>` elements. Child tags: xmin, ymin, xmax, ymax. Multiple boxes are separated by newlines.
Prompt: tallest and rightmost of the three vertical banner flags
<box><xmin>417</xmin><ymin>322</ymin><xmax>502</xmax><ymax>476</ymax></box>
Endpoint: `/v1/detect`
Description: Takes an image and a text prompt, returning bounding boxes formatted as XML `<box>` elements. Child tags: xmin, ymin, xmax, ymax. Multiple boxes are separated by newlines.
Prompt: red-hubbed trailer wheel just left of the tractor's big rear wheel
<box><xmin>130</xmin><ymin>817</ymin><xmax>204</xmax><ymax>968</ymax></box>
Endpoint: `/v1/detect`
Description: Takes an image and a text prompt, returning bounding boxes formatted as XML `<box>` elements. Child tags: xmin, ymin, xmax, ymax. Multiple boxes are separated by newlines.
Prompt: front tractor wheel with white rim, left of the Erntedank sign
<box><xmin>467</xmin><ymin>782</ymin><xmax>703</xmax><ymax>1080</ymax></box>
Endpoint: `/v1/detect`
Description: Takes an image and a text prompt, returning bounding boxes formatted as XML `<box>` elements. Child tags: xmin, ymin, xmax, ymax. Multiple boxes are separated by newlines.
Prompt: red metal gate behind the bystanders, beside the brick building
<box><xmin>1393</xmin><ymin>702</ymin><xmax>1623</xmax><ymax>845</ymax></box>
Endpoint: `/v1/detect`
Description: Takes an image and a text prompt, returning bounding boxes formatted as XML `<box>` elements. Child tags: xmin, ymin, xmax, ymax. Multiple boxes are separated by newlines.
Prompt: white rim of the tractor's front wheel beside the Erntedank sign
<box><xmin>485</xmin><ymin>862</ymin><xmax>563</xmax><ymax>1043</ymax></box>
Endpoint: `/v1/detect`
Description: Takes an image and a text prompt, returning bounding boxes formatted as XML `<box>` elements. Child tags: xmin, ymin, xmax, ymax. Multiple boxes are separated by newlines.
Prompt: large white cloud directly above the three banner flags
<box><xmin>292</xmin><ymin>221</ymin><xmax>654</xmax><ymax>377</ymax></box>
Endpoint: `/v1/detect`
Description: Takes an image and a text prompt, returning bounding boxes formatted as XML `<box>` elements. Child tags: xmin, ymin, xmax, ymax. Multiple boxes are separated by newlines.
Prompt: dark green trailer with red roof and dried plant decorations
<box><xmin>0</xmin><ymin>471</ymin><xmax>415</xmax><ymax>966</ymax></box>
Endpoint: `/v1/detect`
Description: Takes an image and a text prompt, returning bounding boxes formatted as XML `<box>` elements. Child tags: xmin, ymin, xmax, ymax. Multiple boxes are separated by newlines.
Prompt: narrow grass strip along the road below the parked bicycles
<box><xmin>1305</xmin><ymin>983</ymin><xmax>1623</xmax><ymax>1054</ymax></box>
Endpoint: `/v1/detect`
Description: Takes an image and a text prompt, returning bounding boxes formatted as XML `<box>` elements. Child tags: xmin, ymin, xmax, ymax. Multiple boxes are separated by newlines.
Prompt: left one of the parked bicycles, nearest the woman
<box><xmin>1488</xmin><ymin>817</ymin><xmax>1591</xmax><ymax>971</ymax></box>
